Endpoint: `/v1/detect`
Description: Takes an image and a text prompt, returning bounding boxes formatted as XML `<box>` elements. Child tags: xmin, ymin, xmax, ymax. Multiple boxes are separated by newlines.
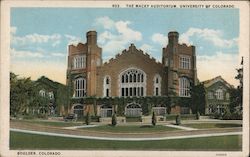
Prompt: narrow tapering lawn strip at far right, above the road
<box><xmin>182</xmin><ymin>123</ymin><xmax>242</xmax><ymax>129</ymax></box>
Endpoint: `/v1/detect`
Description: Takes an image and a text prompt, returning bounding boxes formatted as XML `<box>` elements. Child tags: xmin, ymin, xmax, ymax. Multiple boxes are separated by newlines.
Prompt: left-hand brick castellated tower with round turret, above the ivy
<box><xmin>67</xmin><ymin>31</ymin><xmax>102</xmax><ymax>98</ymax></box>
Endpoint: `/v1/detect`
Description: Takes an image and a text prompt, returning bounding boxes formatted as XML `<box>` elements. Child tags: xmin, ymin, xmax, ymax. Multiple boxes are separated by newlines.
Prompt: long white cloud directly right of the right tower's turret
<box><xmin>180</xmin><ymin>28</ymin><xmax>238</xmax><ymax>48</ymax></box>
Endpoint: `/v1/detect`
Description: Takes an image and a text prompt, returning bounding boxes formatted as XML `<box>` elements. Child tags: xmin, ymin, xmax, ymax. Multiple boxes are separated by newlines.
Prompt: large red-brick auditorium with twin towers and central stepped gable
<box><xmin>66</xmin><ymin>31</ymin><xmax>197</xmax><ymax>116</ymax></box>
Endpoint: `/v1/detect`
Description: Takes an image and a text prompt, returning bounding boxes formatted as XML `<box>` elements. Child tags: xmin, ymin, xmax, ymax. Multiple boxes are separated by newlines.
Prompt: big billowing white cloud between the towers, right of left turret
<box><xmin>95</xmin><ymin>16</ymin><xmax>142</xmax><ymax>56</ymax></box>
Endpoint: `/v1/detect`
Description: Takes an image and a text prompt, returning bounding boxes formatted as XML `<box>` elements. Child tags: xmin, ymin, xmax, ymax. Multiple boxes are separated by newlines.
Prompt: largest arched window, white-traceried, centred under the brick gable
<box><xmin>119</xmin><ymin>68</ymin><xmax>146</xmax><ymax>96</ymax></box>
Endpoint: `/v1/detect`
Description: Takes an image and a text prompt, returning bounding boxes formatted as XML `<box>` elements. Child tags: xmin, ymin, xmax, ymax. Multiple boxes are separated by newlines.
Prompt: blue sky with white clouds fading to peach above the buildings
<box><xmin>10</xmin><ymin>8</ymin><xmax>240</xmax><ymax>86</ymax></box>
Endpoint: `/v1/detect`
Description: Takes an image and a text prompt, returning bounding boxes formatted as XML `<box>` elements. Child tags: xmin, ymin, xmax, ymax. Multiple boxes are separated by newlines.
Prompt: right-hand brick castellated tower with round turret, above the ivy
<box><xmin>162</xmin><ymin>32</ymin><xmax>197</xmax><ymax>97</ymax></box>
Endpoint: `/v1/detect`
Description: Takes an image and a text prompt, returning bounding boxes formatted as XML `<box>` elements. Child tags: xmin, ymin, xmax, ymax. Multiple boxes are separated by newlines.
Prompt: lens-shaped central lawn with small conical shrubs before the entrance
<box><xmin>81</xmin><ymin>125</ymin><xmax>179</xmax><ymax>133</ymax></box>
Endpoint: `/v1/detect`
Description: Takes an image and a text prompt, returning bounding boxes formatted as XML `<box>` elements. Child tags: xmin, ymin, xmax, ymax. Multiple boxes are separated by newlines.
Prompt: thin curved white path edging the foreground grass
<box><xmin>10</xmin><ymin>128</ymin><xmax>242</xmax><ymax>141</ymax></box>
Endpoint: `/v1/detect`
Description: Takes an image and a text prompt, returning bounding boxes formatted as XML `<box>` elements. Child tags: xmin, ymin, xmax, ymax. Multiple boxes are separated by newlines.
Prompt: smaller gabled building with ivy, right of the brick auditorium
<box><xmin>203</xmin><ymin>76</ymin><xmax>233</xmax><ymax>114</ymax></box>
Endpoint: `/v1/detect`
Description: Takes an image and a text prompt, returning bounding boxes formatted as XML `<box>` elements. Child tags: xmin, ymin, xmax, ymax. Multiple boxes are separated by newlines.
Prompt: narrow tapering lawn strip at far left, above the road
<box><xmin>11</xmin><ymin>120</ymin><xmax>83</xmax><ymax>127</ymax></box>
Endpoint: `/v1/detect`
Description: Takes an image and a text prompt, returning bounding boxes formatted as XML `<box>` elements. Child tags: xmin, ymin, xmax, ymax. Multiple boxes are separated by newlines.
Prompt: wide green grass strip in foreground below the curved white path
<box><xmin>10</xmin><ymin>131</ymin><xmax>242</xmax><ymax>151</ymax></box>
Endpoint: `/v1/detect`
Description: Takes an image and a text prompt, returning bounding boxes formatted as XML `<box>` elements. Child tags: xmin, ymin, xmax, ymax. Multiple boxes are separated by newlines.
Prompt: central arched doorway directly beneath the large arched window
<box><xmin>125</xmin><ymin>103</ymin><xmax>142</xmax><ymax>117</ymax></box>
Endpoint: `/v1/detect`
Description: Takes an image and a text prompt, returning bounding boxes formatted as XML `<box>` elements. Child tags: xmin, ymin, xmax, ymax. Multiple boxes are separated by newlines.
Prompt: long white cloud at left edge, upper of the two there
<box><xmin>11</xmin><ymin>32</ymin><xmax>61</xmax><ymax>47</ymax></box>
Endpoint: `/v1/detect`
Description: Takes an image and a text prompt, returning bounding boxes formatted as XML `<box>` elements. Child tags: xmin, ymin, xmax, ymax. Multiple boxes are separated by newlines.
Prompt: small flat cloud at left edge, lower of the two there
<box><xmin>10</xmin><ymin>48</ymin><xmax>44</xmax><ymax>58</ymax></box>
